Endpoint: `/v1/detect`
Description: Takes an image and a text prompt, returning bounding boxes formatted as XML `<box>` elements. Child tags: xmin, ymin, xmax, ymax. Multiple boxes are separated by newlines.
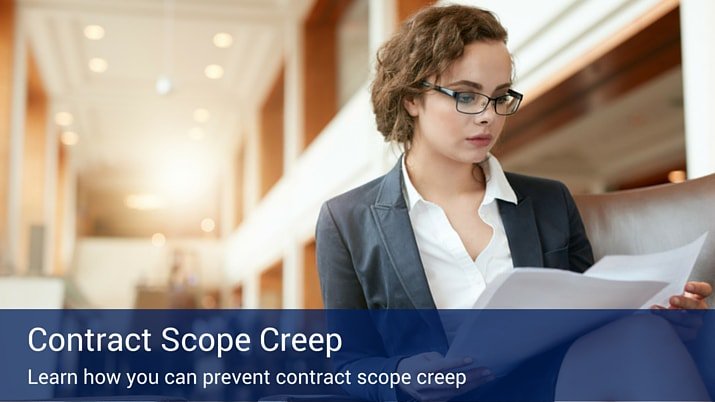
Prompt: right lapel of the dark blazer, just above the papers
<box><xmin>497</xmin><ymin>197</ymin><xmax>544</xmax><ymax>267</ymax></box>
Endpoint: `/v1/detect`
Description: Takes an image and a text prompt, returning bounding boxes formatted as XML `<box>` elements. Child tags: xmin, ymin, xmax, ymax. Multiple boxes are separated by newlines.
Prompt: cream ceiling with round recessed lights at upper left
<box><xmin>19</xmin><ymin>0</ymin><xmax>310</xmax><ymax>188</ymax></box>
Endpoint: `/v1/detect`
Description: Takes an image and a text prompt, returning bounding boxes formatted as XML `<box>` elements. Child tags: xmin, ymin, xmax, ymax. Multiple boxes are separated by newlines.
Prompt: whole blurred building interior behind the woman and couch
<box><xmin>0</xmin><ymin>0</ymin><xmax>715</xmax><ymax>308</ymax></box>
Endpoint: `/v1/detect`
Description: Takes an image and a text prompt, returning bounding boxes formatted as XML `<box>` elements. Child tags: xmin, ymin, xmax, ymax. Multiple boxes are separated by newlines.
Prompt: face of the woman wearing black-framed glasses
<box><xmin>405</xmin><ymin>41</ymin><xmax>511</xmax><ymax>163</ymax></box>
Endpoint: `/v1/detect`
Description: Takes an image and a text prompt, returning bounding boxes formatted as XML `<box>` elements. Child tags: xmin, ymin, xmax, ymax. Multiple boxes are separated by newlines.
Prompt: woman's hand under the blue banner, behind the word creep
<box><xmin>397</xmin><ymin>352</ymin><xmax>494</xmax><ymax>401</ymax></box>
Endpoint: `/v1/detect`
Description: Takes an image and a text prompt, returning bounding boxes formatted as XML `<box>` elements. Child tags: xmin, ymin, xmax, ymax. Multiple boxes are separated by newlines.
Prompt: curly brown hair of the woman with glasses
<box><xmin>371</xmin><ymin>5</ymin><xmax>507</xmax><ymax>147</ymax></box>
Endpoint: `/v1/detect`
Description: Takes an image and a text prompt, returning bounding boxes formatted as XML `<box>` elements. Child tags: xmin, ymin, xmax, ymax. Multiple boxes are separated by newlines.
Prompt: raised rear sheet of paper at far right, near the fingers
<box><xmin>584</xmin><ymin>232</ymin><xmax>708</xmax><ymax>308</ymax></box>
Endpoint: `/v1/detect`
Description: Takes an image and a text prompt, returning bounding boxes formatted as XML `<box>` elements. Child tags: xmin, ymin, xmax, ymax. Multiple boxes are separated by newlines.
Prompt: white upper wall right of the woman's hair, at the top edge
<box><xmin>468</xmin><ymin>0</ymin><xmax>672</xmax><ymax>95</ymax></box>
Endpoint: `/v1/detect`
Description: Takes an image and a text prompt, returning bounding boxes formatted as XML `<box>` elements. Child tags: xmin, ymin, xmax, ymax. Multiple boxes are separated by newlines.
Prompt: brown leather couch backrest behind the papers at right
<box><xmin>574</xmin><ymin>174</ymin><xmax>715</xmax><ymax>284</ymax></box>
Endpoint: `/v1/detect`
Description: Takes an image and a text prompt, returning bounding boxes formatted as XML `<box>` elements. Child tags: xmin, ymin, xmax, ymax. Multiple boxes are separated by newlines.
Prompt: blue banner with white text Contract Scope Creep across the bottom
<box><xmin>0</xmin><ymin>310</ymin><xmax>715</xmax><ymax>401</ymax></box>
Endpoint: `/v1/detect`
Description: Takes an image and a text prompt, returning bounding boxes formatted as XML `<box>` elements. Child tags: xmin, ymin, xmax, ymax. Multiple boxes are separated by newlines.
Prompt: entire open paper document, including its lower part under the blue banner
<box><xmin>447</xmin><ymin>233</ymin><xmax>707</xmax><ymax>376</ymax></box>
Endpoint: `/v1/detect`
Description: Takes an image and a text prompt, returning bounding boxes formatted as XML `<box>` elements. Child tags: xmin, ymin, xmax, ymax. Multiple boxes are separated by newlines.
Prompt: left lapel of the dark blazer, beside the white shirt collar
<box><xmin>370</xmin><ymin>158</ymin><xmax>436</xmax><ymax>309</ymax></box>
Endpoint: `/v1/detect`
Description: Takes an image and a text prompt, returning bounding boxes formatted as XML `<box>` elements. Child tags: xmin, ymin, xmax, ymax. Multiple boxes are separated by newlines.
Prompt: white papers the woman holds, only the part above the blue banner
<box><xmin>474</xmin><ymin>233</ymin><xmax>707</xmax><ymax>309</ymax></box>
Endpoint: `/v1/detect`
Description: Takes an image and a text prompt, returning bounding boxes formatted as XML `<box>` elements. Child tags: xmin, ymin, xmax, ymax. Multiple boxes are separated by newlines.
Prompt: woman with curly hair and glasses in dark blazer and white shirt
<box><xmin>316</xmin><ymin>6</ymin><xmax>712</xmax><ymax>400</ymax></box>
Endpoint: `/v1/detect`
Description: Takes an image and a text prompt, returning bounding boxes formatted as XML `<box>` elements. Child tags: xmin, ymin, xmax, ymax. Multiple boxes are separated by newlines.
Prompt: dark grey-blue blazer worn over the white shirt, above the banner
<box><xmin>316</xmin><ymin>160</ymin><xmax>593</xmax><ymax>309</ymax></box>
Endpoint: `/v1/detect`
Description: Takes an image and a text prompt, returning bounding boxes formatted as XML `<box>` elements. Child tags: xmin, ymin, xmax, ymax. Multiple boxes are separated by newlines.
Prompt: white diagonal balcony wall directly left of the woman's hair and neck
<box><xmin>226</xmin><ymin>89</ymin><xmax>389</xmax><ymax>281</ymax></box>
